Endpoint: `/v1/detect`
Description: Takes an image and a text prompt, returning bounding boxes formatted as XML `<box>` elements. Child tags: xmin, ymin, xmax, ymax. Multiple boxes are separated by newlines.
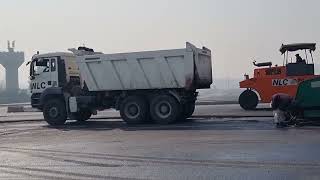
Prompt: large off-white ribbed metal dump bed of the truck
<box><xmin>77</xmin><ymin>43</ymin><xmax>212</xmax><ymax>91</ymax></box>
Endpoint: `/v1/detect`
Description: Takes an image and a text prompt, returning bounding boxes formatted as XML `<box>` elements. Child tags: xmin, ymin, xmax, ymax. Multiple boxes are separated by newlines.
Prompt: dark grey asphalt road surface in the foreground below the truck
<box><xmin>0</xmin><ymin>106</ymin><xmax>320</xmax><ymax>180</ymax></box>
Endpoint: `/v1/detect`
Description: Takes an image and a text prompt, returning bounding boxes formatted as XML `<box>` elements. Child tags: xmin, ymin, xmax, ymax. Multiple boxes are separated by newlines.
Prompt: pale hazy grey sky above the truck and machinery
<box><xmin>0</xmin><ymin>0</ymin><xmax>320</xmax><ymax>87</ymax></box>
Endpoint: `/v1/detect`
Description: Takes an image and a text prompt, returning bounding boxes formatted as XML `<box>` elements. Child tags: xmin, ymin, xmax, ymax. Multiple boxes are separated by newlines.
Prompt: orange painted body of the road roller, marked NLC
<box><xmin>240</xmin><ymin>66</ymin><xmax>319</xmax><ymax>103</ymax></box>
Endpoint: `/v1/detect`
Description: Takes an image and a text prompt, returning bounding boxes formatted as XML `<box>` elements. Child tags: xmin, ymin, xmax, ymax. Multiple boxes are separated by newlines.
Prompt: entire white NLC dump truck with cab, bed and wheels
<box><xmin>30</xmin><ymin>43</ymin><xmax>212</xmax><ymax>126</ymax></box>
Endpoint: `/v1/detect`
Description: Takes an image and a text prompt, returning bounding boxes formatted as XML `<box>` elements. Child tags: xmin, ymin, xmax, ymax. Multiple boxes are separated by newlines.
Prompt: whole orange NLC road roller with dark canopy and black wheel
<box><xmin>239</xmin><ymin>43</ymin><xmax>319</xmax><ymax>110</ymax></box>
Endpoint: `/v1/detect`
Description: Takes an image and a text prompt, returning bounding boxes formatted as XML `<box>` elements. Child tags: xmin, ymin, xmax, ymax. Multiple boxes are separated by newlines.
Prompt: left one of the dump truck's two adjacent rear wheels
<box><xmin>120</xmin><ymin>96</ymin><xmax>148</xmax><ymax>125</ymax></box>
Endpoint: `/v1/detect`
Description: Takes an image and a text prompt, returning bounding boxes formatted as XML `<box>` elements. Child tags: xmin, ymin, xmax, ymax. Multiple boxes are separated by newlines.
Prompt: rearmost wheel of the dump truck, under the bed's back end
<box><xmin>150</xmin><ymin>95</ymin><xmax>181</xmax><ymax>124</ymax></box>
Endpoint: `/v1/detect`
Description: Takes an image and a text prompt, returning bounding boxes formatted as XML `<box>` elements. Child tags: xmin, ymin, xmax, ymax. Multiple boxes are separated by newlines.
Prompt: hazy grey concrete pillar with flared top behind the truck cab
<box><xmin>0</xmin><ymin>41</ymin><xmax>24</xmax><ymax>91</ymax></box>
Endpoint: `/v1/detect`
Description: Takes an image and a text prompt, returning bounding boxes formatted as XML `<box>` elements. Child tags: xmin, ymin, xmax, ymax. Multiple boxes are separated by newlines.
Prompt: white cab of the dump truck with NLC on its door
<box><xmin>30</xmin><ymin>52</ymin><xmax>80</xmax><ymax>109</ymax></box>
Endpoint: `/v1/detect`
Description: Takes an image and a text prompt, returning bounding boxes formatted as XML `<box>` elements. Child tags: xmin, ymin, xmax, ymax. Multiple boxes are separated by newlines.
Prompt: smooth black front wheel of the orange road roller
<box><xmin>239</xmin><ymin>90</ymin><xmax>259</xmax><ymax>110</ymax></box>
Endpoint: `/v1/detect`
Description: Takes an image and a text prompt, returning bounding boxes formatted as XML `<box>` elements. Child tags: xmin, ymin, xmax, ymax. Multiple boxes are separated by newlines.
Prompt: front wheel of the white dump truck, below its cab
<box><xmin>43</xmin><ymin>99</ymin><xmax>67</xmax><ymax>126</ymax></box>
